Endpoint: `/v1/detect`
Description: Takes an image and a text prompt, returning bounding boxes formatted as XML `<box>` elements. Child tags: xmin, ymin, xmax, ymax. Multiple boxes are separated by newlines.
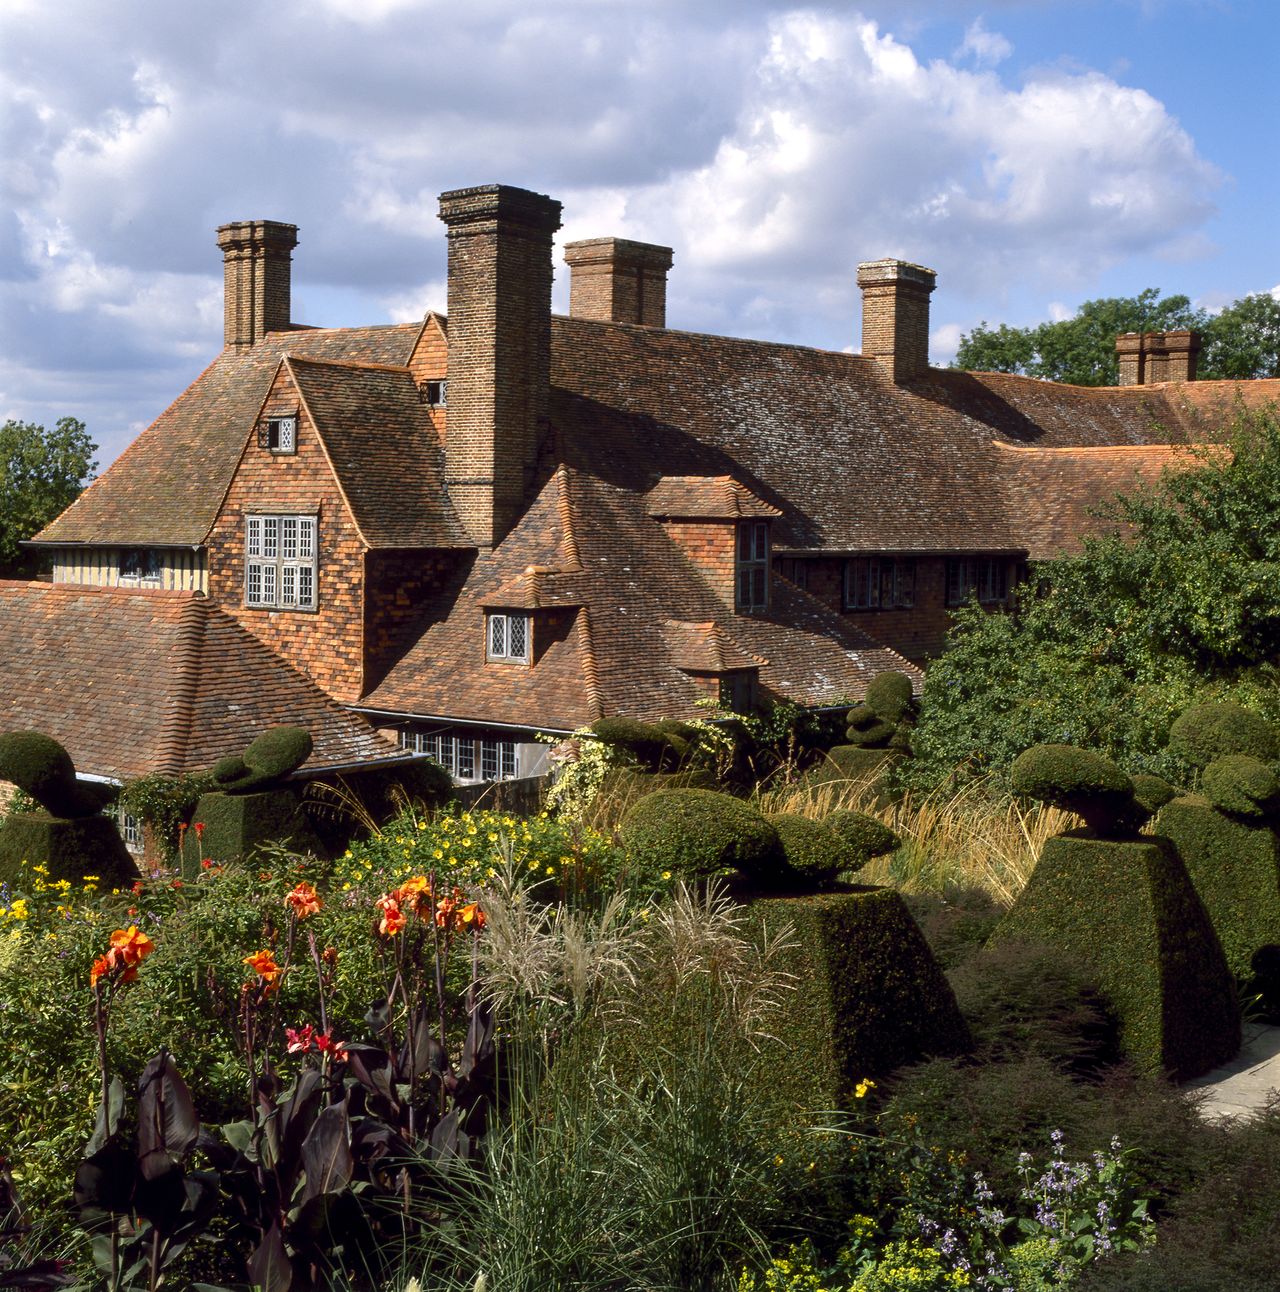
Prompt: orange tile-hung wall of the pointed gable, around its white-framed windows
<box><xmin>208</xmin><ymin>367</ymin><xmax>364</xmax><ymax>702</ymax></box>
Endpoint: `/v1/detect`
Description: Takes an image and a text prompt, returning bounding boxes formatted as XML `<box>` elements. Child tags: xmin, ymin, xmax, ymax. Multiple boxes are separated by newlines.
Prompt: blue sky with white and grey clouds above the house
<box><xmin>0</xmin><ymin>0</ymin><xmax>1280</xmax><ymax>468</ymax></box>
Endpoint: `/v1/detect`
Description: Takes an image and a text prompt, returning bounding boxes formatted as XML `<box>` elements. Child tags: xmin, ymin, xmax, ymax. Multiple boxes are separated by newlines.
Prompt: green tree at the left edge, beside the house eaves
<box><xmin>0</xmin><ymin>417</ymin><xmax>98</xmax><ymax>576</ymax></box>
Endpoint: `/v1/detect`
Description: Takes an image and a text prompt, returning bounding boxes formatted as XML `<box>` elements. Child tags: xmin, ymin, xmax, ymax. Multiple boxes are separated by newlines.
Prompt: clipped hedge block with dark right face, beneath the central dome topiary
<box><xmin>750</xmin><ymin>888</ymin><xmax>970</xmax><ymax>1112</ymax></box>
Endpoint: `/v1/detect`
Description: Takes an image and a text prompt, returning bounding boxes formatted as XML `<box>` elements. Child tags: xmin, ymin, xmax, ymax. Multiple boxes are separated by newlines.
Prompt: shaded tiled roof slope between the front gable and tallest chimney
<box><xmin>284</xmin><ymin>357</ymin><xmax>471</xmax><ymax>548</ymax></box>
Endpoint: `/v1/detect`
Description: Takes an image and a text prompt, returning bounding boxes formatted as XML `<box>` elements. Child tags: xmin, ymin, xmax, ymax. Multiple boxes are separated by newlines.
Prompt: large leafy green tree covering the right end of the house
<box><xmin>912</xmin><ymin>408</ymin><xmax>1280</xmax><ymax>786</ymax></box>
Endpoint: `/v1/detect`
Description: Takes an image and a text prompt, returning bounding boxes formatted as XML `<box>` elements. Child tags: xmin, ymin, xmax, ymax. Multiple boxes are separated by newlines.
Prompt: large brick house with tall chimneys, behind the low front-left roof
<box><xmin>20</xmin><ymin>185</ymin><xmax>1280</xmax><ymax>780</ymax></box>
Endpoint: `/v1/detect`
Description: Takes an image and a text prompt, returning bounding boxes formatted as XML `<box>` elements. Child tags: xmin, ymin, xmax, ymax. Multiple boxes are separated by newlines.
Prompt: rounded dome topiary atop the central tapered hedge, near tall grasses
<box><xmin>621</xmin><ymin>789</ymin><xmax>781</xmax><ymax>879</ymax></box>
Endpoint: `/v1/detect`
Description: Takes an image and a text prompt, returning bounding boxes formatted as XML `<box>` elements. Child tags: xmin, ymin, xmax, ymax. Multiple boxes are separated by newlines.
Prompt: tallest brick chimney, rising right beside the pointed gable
<box><xmin>440</xmin><ymin>183</ymin><xmax>561</xmax><ymax>548</ymax></box>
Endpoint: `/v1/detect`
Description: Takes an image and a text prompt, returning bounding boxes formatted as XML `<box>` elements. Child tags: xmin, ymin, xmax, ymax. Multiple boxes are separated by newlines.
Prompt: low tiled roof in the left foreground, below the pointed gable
<box><xmin>0</xmin><ymin>580</ymin><xmax>394</xmax><ymax>779</ymax></box>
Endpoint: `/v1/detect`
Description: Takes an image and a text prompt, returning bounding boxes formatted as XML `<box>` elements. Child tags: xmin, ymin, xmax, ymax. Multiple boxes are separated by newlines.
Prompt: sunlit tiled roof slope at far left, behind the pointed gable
<box><xmin>36</xmin><ymin>323</ymin><xmax>422</xmax><ymax>547</ymax></box>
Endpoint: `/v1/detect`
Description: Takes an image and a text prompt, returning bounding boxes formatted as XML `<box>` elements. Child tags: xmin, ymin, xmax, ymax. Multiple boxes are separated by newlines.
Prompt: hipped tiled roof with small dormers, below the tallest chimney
<box><xmin>362</xmin><ymin>468</ymin><xmax>918</xmax><ymax>730</ymax></box>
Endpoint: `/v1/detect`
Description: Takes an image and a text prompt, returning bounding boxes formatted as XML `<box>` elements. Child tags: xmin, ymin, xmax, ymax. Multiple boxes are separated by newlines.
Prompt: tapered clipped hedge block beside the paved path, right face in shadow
<box><xmin>992</xmin><ymin>826</ymin><xmax>1240</xmax><ymax>1079</ymax></box>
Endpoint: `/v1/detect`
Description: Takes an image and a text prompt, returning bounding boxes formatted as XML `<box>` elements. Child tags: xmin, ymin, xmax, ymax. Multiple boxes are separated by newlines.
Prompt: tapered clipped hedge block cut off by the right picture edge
<box><xmin>1156</xmin><ymin>796</ymin><xmax>1280</xmax><ymax>992</ymax></box>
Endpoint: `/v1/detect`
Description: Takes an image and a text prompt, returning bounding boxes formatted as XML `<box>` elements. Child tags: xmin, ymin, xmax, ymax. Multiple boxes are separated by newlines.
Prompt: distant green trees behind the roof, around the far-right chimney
<box><xmin>952</xmin><ymin>287</ymin><xmax>1280</xmax><ymax>386</ymax></box>
